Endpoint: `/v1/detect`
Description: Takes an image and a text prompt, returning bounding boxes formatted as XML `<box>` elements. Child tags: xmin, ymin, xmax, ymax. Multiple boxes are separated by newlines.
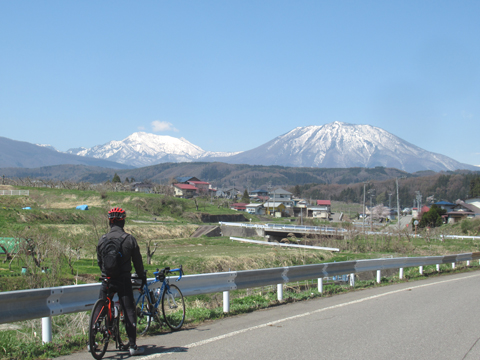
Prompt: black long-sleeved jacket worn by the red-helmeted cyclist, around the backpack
<box><xmin>97</xmin><ymin>225</ymin><xmax>144</xmax><ymax>277</ymax></box>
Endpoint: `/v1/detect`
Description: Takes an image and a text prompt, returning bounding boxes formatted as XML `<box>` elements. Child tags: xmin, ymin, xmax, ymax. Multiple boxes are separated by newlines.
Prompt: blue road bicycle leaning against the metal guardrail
<box><xmin>136</xmin><ymin>265</ymin><xmax>185</xmax><ymax>335</ymax></box>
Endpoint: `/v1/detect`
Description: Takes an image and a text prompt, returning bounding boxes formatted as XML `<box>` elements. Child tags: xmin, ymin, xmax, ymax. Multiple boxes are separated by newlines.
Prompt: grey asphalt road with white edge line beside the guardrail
<box><xmin>58</xmin><ymin>271</ymin><xmax>480</xmax><ymax>360</ymax></box>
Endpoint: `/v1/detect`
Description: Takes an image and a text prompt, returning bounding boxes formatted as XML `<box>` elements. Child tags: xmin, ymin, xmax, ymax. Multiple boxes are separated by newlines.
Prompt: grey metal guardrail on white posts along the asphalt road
<box><xmin>0</xmin><ymin>252</ymin><xmax>480</xmax><ymax>342</ymax></box>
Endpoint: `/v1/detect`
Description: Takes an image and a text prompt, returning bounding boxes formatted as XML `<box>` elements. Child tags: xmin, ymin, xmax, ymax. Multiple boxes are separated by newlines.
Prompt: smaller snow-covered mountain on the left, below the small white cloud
<box><xmin>67</xmin><ymin>132</ymin><xmax>236</xmax><ymax>167</ymax></box>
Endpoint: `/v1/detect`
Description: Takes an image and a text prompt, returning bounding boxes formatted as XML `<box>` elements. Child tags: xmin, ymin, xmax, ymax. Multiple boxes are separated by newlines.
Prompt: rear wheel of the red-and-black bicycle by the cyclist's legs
<box><xmin>88</xmin><ymin>299</ymin><xmax>110</xmax><ymax>360</ymax></box>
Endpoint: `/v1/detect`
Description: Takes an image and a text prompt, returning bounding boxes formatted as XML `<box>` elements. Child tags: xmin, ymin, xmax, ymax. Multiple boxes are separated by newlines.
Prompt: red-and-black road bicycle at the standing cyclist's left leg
<box><xmin>88</xmin><ymin>277</ymin><xmax>129</xmax><ymax>360</ymax></box>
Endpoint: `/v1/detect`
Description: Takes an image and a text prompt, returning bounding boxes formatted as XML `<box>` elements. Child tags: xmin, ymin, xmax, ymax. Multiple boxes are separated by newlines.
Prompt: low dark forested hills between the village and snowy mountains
<box><xmin>0</xmin><ymin>163</ymin><xmax>480</xmax><ymax>207</ymax></box>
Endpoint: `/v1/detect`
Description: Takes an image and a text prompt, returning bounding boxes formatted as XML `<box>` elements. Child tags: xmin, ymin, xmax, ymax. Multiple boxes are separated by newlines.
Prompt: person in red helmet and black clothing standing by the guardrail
<box><xmin>97</xmin><ymin>207</ymin><xmax>147</xmax><ymax>356</ymax></box>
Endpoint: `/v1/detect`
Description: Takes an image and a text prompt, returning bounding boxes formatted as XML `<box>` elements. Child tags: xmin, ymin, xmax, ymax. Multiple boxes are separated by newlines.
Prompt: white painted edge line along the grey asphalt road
<box><xmin>138</xmin><ymin>274</ymin><xmax>480</xmax><ymax>360</ymax></box>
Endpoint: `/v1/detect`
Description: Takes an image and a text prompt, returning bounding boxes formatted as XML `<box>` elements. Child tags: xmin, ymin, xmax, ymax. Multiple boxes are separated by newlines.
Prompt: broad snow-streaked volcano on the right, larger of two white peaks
<box><xmin>206</xmin><ymin>121</ymin><xmax>478</xmax><ymax>172</ymax></box>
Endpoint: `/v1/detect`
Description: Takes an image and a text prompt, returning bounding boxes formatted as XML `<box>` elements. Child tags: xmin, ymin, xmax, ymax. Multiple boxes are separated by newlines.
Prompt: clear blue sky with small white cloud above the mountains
<box><xmin>0</xmin><ymin>0</ymin><xmax>480</xmax><ymax>165</ymax></box>
